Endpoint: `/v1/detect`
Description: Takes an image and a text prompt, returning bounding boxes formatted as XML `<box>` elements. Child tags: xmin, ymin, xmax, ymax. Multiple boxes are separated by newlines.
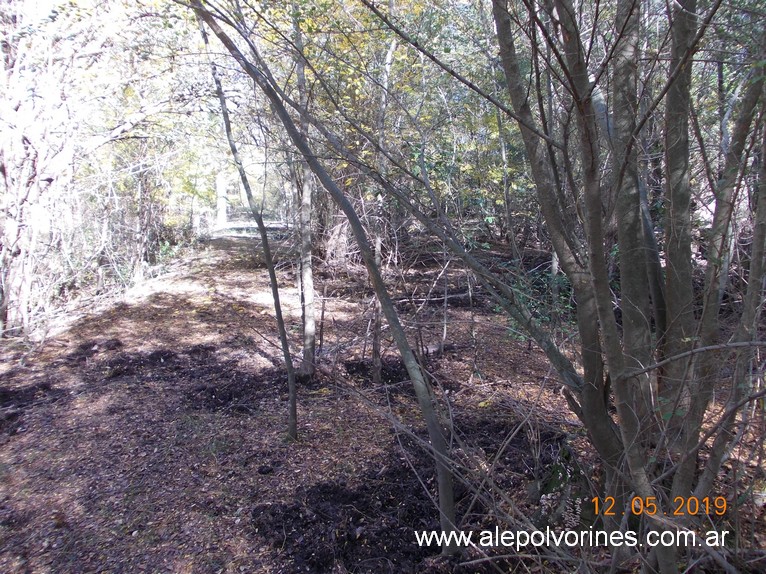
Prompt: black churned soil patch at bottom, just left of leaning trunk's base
<box><xmin>251</xmin><ymin>456</ymin><xmax>439</xmax><ymax>574</ymax></box>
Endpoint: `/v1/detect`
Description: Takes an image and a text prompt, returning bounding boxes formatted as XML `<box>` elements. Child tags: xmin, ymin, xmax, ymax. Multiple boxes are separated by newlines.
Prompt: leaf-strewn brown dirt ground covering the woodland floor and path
<box><xmin>0</xmin><ymin>239</ymin><xmax>763</xmax><ymax>574</ymax></box>
